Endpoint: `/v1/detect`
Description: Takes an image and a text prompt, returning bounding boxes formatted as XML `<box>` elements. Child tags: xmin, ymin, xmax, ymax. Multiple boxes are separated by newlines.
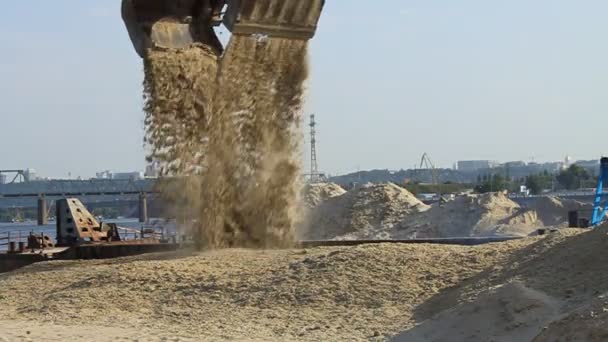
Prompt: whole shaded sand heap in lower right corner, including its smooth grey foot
<box><xmin>395</xmin><ymin>226</ymin><xmax>608</xmax><ymax>341</ymax></box>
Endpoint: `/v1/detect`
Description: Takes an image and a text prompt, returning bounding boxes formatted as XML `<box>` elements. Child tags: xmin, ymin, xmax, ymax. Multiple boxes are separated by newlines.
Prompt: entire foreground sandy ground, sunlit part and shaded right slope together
<box><xmin>0</xmin><ymin>228</ymin><xmax>608</xmax><ymax>341</ymax></box>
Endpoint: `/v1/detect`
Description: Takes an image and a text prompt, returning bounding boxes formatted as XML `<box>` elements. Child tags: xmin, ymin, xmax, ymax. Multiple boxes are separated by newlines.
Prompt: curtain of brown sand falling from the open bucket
<box><xmin>144</xmin><ymin>35</ymin><xmax>308</xmax><ymax>247</ymax></box>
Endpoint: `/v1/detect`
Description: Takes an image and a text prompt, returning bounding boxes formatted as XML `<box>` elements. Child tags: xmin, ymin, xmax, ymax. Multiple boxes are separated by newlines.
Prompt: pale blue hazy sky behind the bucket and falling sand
<box><xmin>0</xmin><ymin>0</ymin><xmax>608</xmax><ymax>177</ymax></box>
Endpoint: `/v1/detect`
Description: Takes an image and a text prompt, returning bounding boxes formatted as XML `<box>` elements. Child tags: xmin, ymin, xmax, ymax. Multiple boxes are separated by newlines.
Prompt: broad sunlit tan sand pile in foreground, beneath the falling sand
<box><xmin>0</xmin><ymin>239</ymin><xmax>536</xmax><ymax>341</ymax></box>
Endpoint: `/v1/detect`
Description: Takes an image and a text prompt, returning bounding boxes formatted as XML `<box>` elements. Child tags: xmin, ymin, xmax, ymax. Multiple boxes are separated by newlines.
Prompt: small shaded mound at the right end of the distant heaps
<box><xmin>530</xmin><ymin>196</ymin><xmax>593</xmax><ymax>226</ymax></box>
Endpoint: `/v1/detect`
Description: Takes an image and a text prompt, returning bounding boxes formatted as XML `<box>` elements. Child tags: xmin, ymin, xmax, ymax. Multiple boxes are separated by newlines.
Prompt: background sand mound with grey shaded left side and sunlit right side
<box><xmin>389</xmin><ymin>192</ymin><xmax>539</xmax><ymax>239</ymax></box>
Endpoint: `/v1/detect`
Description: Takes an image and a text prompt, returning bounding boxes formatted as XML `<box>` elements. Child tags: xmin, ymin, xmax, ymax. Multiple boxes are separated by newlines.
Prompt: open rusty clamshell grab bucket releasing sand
<box><xmin>122</xmin><ymin>0</ymin><xmax>325</xmax><ymax>58</ymax></box>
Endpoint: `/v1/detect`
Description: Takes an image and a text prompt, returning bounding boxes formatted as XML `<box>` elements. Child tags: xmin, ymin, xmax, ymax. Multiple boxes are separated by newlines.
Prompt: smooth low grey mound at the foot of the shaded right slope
<box><xmin>391</xmin><ymin>282</ymin><xmax>559</xmax><ymax>342</ymax></box>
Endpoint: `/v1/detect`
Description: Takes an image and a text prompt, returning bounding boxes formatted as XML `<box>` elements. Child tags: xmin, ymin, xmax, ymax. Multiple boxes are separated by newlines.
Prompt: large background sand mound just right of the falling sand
<box><xmin>301</xmin><ymin>183</ymin><xmax>429</xmax><ymax>240</ymax></box>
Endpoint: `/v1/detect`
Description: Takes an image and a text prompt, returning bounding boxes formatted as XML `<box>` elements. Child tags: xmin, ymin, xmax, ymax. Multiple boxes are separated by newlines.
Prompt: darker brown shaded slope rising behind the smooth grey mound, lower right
<box><xmin>408</xmin><ymin>225</ymin><xmax>608</xmax><ymax>341</ymax></box>
